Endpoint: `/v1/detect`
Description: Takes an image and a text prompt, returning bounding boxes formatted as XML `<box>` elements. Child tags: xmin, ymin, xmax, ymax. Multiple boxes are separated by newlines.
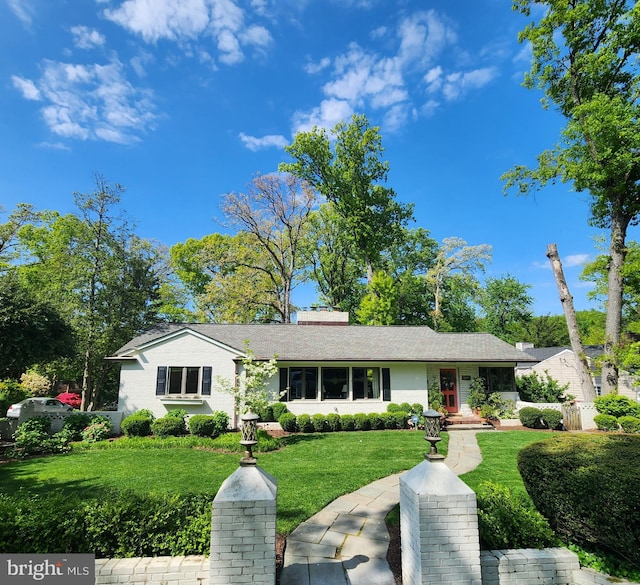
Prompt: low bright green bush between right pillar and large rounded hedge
<box><xmin>476</xmin><ymin>482</ymin><xmax>558</xmax><ymax>550</ymax></box>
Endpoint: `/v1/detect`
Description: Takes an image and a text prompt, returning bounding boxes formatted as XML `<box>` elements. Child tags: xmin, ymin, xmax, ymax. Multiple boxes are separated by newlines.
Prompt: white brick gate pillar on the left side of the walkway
<box><xmin>209</xmin><ymin>460</ymin><xmax>277</xmax><ymax>585</ymax></box>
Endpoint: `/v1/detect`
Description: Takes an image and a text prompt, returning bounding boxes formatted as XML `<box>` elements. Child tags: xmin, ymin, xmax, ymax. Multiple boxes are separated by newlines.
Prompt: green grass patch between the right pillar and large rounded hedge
<box><xmin>460</xmin><ymin>431</ymin><xmax>558</xmax><ymax>494</ymax></box>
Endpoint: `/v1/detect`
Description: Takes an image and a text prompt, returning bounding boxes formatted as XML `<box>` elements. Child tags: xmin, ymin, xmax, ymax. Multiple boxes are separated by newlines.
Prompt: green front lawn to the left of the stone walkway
<box><xmin>0</xmin><ymin>431</ymin><xmax>440</xmax><ymax>534</ymax></box>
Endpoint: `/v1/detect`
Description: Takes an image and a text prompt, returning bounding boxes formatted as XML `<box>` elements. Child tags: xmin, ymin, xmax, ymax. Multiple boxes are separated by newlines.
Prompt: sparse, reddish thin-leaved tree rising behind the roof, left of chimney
<box><xmin>221</xmin><ymin>174</ymin><xmax>317</xmax><ymax>323</ymax></box>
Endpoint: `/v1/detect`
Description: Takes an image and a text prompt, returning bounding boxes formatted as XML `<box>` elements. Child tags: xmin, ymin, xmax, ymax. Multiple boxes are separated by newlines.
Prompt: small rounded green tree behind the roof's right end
<box><xmin>480</xmin><ymin>274</ymin><xmax>533</xmax><ymax>344</ymax></box>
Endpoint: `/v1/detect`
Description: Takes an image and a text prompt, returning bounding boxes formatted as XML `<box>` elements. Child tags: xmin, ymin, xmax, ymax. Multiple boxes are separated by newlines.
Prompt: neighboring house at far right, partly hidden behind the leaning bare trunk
<box><xmin>516</xmin><ymin>343</ymin><xmax>638</xmax><ymax>402</ymax></box>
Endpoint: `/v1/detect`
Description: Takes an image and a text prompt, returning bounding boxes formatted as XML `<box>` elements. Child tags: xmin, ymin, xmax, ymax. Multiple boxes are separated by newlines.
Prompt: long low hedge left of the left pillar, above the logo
<box><xmin>0</xmin><ymin>490</ymin><xmax>211</xmax><ymax>558</ymax></box>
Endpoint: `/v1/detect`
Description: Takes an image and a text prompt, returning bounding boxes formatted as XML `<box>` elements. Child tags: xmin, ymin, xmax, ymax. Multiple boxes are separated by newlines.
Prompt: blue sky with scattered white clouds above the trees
<box><xmin>0</xmin><ymin>0</ymin><xmax>637</xmax><ymax>314</ymax></box>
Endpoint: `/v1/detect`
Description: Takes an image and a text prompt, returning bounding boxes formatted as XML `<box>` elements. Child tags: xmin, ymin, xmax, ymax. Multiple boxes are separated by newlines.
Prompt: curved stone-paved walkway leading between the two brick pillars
<box><xmin>280</xmin><ymin>429</ymin><xmax>482</xmax><ymax>585</ymax></box>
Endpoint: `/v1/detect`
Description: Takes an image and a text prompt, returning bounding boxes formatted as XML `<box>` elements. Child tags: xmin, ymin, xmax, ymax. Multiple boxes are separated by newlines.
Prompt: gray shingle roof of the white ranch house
<box><xmin>116</xmin><ymin>323</ymin><xmax>537</xmax><ymax>362</ymax></box>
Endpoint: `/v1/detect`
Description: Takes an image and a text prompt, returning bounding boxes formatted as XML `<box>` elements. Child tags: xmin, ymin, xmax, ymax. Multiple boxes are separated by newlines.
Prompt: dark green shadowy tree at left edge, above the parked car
<box><xmin>0</xmin><ymin>274</ymin><xmax>74</xmax><ymax>379</ymax></box>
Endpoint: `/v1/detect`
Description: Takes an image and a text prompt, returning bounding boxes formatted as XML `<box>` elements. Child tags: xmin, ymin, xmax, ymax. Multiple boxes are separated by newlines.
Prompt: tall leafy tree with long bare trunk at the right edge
<box><xmin>503</xmin><ymin>0</ymin><xmax>640</xmax><ymax>393</ymax></box>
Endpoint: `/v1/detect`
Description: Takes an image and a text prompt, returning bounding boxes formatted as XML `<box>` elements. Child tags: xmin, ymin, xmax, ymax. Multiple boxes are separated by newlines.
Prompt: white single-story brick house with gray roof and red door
<box><xmin>110</xmin><ymin>311</ymin><xmax>536</xmax><ymax>420</ymax></box>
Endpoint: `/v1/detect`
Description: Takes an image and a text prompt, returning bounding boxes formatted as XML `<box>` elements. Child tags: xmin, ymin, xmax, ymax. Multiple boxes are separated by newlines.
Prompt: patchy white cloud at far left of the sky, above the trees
<box><xmin>14</xmin><ymin>59</ymin><xmax>157</xmax><ymax>143</ymax></box>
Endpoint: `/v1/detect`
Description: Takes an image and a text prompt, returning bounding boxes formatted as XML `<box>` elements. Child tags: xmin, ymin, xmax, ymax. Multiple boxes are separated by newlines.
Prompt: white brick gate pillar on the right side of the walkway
<box><xmin>400</xmin><ymin>459</ymin><xmax>482</xmax><ymax>585</ymax></box>
